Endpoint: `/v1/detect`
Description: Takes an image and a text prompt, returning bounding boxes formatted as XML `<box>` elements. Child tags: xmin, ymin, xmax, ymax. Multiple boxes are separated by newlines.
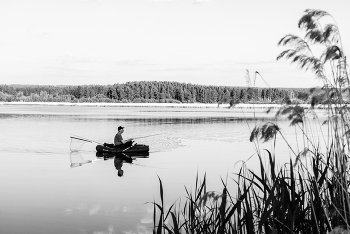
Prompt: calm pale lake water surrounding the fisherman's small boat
<box><xmin>0</xmin><ymin>105</ymin><xmax>326</xmax><ymax>234</ymax></box>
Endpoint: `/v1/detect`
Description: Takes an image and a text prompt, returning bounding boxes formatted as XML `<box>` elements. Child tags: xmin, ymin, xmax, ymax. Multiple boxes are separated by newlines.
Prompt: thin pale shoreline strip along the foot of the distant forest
<box><xmin>0</xmin><ymin>102</ymin><xmax>316</xmax><ymax>109</ymax></box>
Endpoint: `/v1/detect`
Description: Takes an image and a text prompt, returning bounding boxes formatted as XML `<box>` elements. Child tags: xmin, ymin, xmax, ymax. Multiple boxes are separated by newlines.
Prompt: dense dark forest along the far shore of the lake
<box><xmin>0</xmin><ymin>81</ymin><xmax>309</xmax><ymax>104</ymax></box>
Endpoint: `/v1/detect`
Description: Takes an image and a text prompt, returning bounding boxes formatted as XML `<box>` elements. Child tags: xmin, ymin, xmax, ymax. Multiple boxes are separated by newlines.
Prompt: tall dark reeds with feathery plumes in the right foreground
<box><xmin>153</xmin><ymin>10</ymin><xmax>350</xmax><ymax>234</ymax></box>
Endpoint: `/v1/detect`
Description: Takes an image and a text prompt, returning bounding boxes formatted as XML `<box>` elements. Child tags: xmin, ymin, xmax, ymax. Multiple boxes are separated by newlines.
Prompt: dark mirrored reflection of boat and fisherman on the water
<box><xmin>96</xmin><ymin>152</ymin><xmax>149</xmax><ymax>177</ymax></box>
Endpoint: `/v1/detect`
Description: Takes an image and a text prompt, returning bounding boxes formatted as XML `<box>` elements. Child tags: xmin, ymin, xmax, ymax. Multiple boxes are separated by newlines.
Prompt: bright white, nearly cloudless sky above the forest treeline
<box><xmin>0</xmin><ymin>0</ymin><xmax>350</xmax><ymax>87</ymax></box>
